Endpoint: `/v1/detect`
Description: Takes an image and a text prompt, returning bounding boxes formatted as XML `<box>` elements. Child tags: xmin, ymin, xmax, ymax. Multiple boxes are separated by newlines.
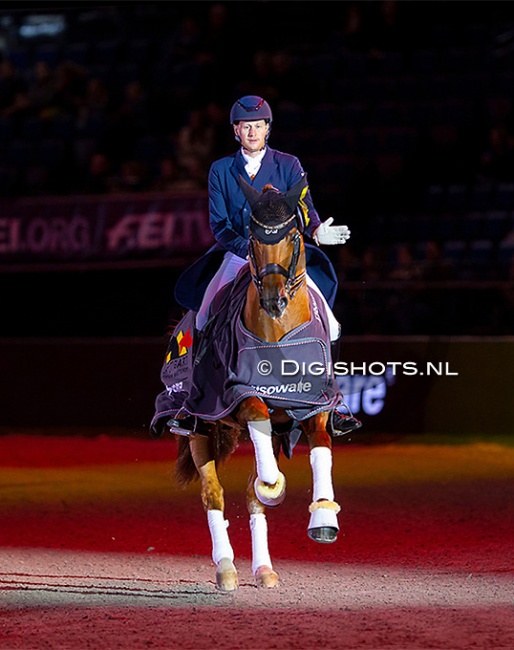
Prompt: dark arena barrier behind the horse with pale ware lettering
<box><xmin>0</xmin><ymin>337</ymin><xmax>514</xmax><ymax>435</ymax></box>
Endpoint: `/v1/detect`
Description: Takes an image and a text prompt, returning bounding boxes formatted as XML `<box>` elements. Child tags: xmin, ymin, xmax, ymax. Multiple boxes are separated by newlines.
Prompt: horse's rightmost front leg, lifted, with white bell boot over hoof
<box><xmin>301</xmin><ymin>413</ymin><xmax>341</xmax><ymax>544</ymax></box>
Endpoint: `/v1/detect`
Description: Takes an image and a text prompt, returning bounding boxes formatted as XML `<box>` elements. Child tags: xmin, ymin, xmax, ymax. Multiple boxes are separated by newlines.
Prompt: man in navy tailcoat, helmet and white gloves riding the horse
<box><xmin>151</xmin><ymin>95</ymin><xmax>360</xmax><ymax>436</ymax></box>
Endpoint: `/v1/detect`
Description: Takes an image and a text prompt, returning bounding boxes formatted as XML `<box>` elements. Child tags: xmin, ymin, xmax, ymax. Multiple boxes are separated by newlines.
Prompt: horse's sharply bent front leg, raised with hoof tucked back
<box><xmin>236</xmin><ymin>397</ymin><xmax>286</xmax><ymax>506</ymax></box>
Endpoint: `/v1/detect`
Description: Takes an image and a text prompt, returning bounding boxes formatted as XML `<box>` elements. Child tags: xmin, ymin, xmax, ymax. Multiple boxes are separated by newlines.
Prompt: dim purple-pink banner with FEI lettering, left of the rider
<box><xmin>0</xmin><ymin>192</ymin><xmax>213</xmax><ymax>270</ymax></box>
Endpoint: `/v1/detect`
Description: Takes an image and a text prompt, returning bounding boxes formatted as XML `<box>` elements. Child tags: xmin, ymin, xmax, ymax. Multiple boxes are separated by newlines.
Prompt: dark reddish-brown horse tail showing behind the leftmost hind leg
<box><xmin>175</xmin><ymin>422</ymin><xmax>240</xmax><ymax>486</ymax></box>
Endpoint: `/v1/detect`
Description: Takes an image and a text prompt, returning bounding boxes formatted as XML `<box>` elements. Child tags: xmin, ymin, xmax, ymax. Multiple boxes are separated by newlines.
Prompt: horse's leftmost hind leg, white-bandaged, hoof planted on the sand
<box><xmin>189</xmin><ymin>435</ymin><xmax>238</xmax><ymax>592</ymax></box>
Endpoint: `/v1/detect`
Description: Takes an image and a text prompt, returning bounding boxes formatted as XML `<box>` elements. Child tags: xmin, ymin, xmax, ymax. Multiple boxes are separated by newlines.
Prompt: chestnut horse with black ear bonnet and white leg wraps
<box><xmin>166</xmin><ymin>179</ymin><xmax>340</xmax><ymax>592</ymax></box>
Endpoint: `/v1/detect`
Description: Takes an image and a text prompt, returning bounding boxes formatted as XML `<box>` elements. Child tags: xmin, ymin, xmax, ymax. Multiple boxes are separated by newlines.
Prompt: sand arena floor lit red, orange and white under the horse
<box><xmin>0</xmin><ymin>435</ymin><xmax>514</xmax><ymax>650</ymax></box>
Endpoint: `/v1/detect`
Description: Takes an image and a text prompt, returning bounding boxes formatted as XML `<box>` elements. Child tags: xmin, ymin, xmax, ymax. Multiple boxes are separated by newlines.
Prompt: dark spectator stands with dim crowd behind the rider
<box><xmin>0</xmin><ymin>0</ymin><xmax>514</xmax><ymax>330</ymax></box>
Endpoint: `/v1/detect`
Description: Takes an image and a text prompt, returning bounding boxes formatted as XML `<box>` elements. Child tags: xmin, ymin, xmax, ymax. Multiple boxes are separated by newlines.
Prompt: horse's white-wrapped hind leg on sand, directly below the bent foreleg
<box><xmin>246</xmin><ymin>438</ymin><xmax>280</xmax><ymax>587</ymax></box>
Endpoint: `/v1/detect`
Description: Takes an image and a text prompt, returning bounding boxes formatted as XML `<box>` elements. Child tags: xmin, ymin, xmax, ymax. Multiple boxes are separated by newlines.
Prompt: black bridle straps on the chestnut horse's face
<box><xmin>248</xmin><ymin>214</ymin><xmax>306</xmax><ymax>298</ymax></box>
